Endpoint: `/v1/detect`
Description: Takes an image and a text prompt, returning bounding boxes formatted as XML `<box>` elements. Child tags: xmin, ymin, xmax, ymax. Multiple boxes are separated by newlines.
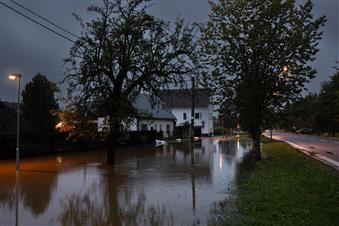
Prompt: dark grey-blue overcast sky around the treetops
<box><xmin>0</xmin><ymin>0</ymin><xmax>339</xmax><ymax>101</ymax></box>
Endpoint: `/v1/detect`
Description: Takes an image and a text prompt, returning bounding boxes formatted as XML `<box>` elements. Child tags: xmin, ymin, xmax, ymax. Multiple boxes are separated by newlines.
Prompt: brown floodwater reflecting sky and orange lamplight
<box><xmin>0</xmin><ymin>139</ymin><xmax>251</xmax><ymax>226</ymax></box>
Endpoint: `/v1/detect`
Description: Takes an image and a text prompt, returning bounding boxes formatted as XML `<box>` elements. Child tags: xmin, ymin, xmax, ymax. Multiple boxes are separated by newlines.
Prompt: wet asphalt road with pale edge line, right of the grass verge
<box><xmin>265</xmin><ymin>132</ymin><xmax>339</xmax><ymax>169</ymax></box>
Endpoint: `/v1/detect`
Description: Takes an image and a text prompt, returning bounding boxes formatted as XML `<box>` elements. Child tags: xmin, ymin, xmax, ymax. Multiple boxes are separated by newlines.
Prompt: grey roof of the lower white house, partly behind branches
<box><xmin>133</xmin><ymin>94</ymin><xmax>176</xmax><ymax>120</ymax></box>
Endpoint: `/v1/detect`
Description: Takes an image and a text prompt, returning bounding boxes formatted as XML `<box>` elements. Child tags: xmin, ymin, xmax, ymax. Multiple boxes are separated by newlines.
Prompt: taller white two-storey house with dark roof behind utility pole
<box><xmin>161</xmin><ymin>89</ymin><xmax>213</xmax><ymax>135</ymax></box>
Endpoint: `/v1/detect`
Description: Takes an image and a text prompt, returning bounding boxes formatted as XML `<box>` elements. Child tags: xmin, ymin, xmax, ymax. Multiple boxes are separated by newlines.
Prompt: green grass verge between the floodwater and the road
<box><xmin>228</xmin><ymin>138</ymin><xmax>339</xmax><ymax>226</ymax></box>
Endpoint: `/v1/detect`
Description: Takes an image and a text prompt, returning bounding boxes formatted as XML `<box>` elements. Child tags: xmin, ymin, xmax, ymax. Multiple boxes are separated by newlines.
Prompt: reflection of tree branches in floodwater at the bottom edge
<box><xmin>52</xmin><ymin>185</ymin><xmax>173</xmax><ymax>226</ymax></box>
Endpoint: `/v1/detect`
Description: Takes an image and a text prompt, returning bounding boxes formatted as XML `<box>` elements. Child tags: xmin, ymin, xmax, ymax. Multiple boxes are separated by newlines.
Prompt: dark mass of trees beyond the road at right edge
<box><xmin>281</xmin><ymin>71</ymin><xmax>339</xmax><ymax>136</ymax></box>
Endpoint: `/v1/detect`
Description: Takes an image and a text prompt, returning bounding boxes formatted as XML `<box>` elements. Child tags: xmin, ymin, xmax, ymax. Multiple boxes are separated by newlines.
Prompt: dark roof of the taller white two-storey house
<box><xmin>161</xmin><ymin>89</ymin><xmax>210</xmax><ymax>108</ymax></box>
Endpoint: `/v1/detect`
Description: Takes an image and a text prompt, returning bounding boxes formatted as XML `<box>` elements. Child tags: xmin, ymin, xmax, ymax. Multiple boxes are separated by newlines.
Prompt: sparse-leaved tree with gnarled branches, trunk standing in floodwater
<box><xmin>65</xmin><ymin>0</ymin><xmax>196</xmax><ymax>164</ymax></box>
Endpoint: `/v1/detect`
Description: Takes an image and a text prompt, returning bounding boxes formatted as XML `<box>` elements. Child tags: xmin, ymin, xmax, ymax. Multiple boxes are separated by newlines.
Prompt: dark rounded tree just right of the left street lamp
<box><xmin>21</xmin><ymin>73</ymin><xmax>59</xmax><ymax>136</ymax></box>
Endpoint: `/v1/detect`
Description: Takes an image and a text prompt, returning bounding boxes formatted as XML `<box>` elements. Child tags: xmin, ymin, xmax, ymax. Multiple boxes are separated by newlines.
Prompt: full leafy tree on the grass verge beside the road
<box><xmin>203</xmin><ymin>0</ymin><xmax>326</xmax><ymax>160</ymax></box>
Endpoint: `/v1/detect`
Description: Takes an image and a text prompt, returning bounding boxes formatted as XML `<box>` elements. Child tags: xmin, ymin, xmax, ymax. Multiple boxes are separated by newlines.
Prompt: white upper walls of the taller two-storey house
<box><xmin>171</xmin><ymin>105</ymin><xmax>213</xmax><ymax>135</ymax></box>
